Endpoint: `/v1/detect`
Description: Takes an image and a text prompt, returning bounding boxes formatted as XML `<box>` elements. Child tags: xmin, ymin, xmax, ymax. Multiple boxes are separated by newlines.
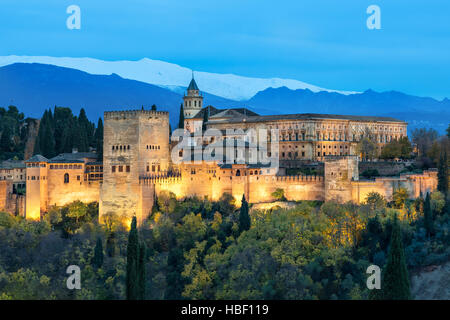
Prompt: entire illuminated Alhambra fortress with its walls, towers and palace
<box><xmin>0</xmin><ymin>79</ymin><xmax>437</xmax><ymax>221</ymax></box>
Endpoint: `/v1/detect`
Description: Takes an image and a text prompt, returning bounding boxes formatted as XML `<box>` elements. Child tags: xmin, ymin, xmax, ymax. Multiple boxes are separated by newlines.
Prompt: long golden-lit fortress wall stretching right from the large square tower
<box><xmin>141</xmin><ymin>156</ymin><xmax>437</xmax><ymax>218</ymax></box>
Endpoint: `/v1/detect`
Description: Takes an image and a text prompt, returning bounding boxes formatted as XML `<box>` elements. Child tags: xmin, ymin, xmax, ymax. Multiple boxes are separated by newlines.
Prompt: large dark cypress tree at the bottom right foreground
<box><xmin>381</xmin><ymin>216</ymin><xmax>411</xmax><ymax>300</ymax></box>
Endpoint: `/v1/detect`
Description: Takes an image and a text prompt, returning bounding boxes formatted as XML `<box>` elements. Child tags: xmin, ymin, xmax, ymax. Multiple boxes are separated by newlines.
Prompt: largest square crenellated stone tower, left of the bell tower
<box><xmin>99</xmin><ymin>110</ymin><xmax>170</xmax><ymax>225</ymax></box>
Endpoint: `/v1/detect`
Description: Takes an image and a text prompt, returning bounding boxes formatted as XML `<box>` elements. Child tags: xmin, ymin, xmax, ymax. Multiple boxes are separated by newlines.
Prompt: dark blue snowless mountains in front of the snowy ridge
<box><xmin>0</xmin><ymin>59</ymin><xmax>450</xmax><ymax>133</ymax></box>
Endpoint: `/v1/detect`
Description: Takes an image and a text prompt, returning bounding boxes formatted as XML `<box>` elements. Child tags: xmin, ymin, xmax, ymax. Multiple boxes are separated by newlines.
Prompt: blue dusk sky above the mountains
<box><xmin>0</xmin><ymin>0</ymin><xmax>450</xmax><ymax>99</ymax></box>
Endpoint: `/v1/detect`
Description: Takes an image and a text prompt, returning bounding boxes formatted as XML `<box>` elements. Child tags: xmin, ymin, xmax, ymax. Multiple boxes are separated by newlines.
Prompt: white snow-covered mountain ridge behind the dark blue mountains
<box><xmin>0</xmin><ymin>56</ymin><xmax>355</xmax><ymax>101</ymax></box>
